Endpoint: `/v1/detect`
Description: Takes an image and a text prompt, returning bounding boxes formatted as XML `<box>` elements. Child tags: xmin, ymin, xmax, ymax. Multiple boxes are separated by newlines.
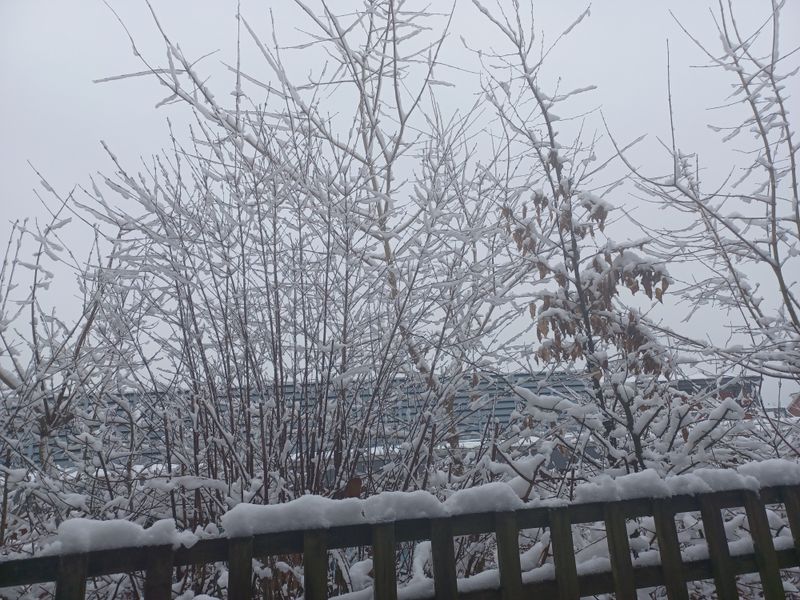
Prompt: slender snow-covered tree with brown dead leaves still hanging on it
<box><xmin>478</xmin><ymin>4</ymin><xmax>742</xmax><ymax>482</ymax></box>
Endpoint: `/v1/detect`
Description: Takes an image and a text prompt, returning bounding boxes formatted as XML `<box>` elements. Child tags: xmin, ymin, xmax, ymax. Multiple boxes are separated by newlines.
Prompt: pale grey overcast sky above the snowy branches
<box><xmin>0</xmin><ymin>0</ymin><xmax>800</xmax><ymax>404</ymax></box>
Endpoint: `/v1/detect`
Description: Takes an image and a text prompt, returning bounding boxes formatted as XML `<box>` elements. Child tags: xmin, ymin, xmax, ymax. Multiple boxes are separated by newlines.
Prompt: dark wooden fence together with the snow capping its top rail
<box><xmin>0</xmin><ymin>461</ymin><xmax>800</xmax><ymax>600</ymax></box>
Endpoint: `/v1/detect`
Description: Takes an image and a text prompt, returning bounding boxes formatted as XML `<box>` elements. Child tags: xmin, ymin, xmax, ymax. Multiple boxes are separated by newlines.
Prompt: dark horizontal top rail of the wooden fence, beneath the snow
<box><xmin>0</xmin><ymin>485</ymin><xmax>800</xmax><ymax>587</ymax></box>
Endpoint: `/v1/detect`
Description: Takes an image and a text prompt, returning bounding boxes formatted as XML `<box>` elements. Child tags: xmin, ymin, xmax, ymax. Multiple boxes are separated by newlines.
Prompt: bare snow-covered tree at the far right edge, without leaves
<box><xmin>622</xmin><ymin>2</ymin><xmax>800</xmax><ymax>382</ymax></box>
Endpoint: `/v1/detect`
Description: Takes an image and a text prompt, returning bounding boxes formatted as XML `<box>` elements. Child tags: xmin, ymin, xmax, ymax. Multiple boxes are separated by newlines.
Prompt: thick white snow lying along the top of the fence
<box><xmin>42</xmin><ymin>459</ymin><xmax>800</xmax><ymax>554</ymax></box>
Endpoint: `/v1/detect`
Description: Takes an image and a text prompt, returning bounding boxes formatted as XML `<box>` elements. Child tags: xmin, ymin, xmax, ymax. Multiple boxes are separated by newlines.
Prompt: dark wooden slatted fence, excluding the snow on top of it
<box><xmin>0</xmin><ymin>486</ymin><xmax>800</xmax><ymax>600</ymax></box>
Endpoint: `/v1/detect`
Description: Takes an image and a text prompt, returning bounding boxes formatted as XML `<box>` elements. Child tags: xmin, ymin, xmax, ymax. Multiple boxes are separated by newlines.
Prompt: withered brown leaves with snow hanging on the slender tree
<box><xmin>501</xmin><ymin>197</ymin><xmax>670</xmax><ymax>374</ymax></box>
